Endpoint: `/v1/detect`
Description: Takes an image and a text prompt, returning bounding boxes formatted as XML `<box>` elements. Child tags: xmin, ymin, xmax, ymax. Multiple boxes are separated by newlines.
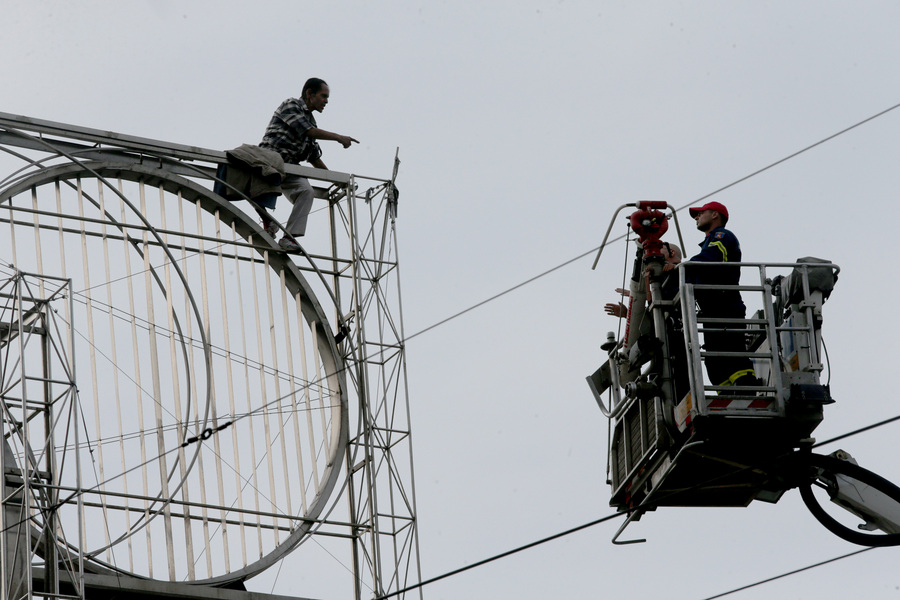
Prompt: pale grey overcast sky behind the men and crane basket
<box><xmin>0</xmin><ymin>0</ymin><xmax>900</xmax><ymax>600</ymax></box>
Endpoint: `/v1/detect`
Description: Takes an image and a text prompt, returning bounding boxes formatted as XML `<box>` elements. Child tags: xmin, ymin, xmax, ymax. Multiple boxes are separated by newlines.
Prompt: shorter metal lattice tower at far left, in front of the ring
<box><xmin>0</xmin><ymin>272</ymin><xmax>84</xmax><ymax>600</ymax></box>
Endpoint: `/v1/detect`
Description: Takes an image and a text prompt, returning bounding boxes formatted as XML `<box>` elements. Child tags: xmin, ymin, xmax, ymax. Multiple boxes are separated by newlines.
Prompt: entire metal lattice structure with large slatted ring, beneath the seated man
<box><xmin>0</xmin><ymin>113</ymin><xmax>420</xmax><ymax>598</ymax></box>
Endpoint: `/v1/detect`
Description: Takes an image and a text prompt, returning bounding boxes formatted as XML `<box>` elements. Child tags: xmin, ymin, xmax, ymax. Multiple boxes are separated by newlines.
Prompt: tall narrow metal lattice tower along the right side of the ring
<box><xmin>331</xmin><ymin>163</ymin><xmax>421</xmax><ymax>598</ymax></box>
